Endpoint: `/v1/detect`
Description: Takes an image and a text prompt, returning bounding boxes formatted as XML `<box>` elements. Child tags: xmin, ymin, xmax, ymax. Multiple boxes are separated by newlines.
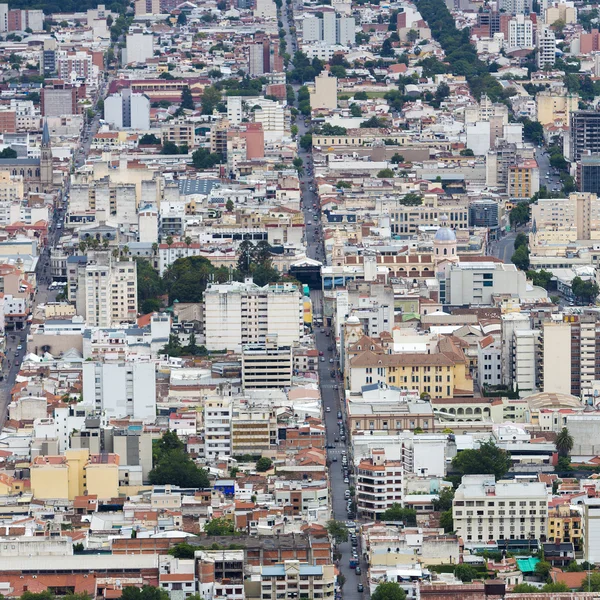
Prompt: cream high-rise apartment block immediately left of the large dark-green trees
<box><xmin>75</xmin><ymin>251</ymin><xmax>137</xmax><ymax>327</ymax></box>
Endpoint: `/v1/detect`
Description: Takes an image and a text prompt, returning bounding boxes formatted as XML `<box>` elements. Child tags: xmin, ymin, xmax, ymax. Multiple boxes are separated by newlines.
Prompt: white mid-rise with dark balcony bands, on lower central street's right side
<box><xmin>356</xmin><ymin>448</ymin><xmax>404</xmax><ymax>520</ymax></box>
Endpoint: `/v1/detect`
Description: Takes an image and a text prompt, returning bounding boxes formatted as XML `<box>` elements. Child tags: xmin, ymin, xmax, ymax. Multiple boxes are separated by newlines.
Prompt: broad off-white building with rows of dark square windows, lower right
<box><xmin>452</xmin><ymin>475</ymin><xmax>548</xmax><ymax>545</ymax></box>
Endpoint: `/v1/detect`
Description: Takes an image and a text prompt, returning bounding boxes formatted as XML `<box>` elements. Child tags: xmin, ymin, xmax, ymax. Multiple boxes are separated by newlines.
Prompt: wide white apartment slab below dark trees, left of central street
<box><xmin>204</xmin><ymin>279</ymin><xmax>304</xmax><ymax>352</ymax></box>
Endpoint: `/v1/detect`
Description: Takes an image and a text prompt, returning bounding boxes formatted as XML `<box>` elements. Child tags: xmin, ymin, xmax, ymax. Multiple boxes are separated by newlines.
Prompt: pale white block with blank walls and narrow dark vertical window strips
<box><xmin>82</xmin><ymin>361</ymin><xmax>156</xmax><ymax>422</ymax></box>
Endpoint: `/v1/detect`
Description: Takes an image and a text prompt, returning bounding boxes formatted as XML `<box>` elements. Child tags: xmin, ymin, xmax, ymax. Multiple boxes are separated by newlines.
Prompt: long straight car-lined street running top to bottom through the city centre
<box><xmin>281</xmin><ymin>4</ymin><xmax>368</xmax><ymax>600</ymax></box>
